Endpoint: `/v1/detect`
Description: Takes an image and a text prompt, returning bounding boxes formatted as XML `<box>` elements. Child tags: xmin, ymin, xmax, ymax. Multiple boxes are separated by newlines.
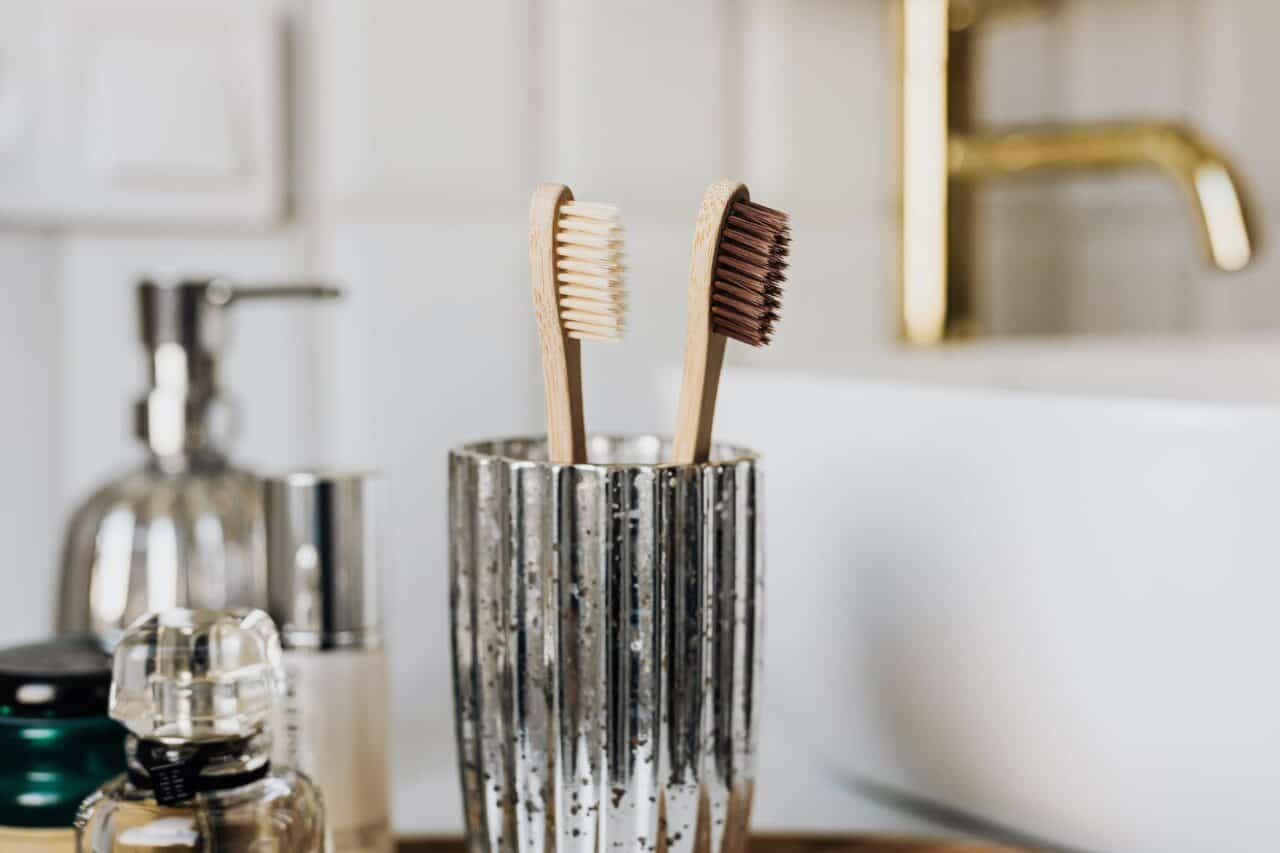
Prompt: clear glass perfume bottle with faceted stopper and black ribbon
<box><xmin>76</xmin><ymin>610</ymin><xmax>325</xmax><ymax>853</ymax></box>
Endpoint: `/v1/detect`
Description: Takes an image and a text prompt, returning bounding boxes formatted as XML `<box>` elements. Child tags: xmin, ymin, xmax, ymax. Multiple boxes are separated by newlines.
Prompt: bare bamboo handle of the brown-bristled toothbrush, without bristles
<box><xmin>672</xmin><ymin>181</ymin><xmax>749</xmax><ymax>465</ymax></box>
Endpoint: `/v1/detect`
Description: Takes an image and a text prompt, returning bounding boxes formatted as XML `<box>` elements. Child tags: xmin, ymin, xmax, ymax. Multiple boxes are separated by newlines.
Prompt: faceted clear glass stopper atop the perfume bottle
<box><xmin>110</xmin><ymin>610</ymin><xmax>284</xmax><ymax>740</ymax></box>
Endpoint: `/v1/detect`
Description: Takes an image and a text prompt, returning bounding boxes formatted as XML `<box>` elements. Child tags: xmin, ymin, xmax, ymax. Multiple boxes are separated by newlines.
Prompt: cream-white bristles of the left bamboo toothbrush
<box><xmin>556</xmin><ymin>201</ymin><xmax>627</xmax><ymax>341</ymax></box>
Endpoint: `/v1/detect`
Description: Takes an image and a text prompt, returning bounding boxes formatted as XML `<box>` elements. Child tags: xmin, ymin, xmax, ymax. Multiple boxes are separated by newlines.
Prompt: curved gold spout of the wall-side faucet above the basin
<box><xmin>947</xmin><ymin>122</ymin><xmax>1257</xmax><ymax>272</ymax></box>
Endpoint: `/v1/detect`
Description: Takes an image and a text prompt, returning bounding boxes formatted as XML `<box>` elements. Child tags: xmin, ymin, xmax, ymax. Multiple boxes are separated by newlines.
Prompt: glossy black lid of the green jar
<box><xmin>0</xmin><ymin>638</ymin><xmax>111</xmax><ymax>719</ymax></box>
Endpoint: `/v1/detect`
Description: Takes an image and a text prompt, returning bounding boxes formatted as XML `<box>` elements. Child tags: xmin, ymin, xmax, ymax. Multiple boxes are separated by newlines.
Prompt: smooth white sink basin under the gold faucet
<box><xmin>717</xmin><ymin>356</ymin><xmax>1280</xmax><ymax>853</ymax></box>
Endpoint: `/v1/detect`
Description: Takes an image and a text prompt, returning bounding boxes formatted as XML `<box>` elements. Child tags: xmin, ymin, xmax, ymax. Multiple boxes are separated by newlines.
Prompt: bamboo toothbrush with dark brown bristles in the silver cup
<box><xmin>673</xmin><ymin>175</ymin><xmax>791</xmax><ymax>465</ymax></box>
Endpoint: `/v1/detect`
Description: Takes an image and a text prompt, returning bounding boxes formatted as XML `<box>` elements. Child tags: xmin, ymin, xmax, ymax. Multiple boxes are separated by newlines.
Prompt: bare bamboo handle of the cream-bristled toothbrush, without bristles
<box><xmin>529</xmin><ymin>183</ymin><xmax>586</xmax><ymax>464</ymax></box>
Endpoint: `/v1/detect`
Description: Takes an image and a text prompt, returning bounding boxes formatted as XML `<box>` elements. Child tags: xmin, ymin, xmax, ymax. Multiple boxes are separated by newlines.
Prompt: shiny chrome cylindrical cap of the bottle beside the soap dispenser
<box><xmin>262</xmin><ymin>471</ymin><xmax>381</xmax><ymax>649</ymax></box>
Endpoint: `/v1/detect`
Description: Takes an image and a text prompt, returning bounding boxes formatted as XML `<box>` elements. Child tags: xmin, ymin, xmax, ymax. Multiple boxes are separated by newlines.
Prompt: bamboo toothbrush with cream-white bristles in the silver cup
<box><xmin>529</xmin><ymin>183</ymin><xmax>627</xmax><ymax>464</ymax></box>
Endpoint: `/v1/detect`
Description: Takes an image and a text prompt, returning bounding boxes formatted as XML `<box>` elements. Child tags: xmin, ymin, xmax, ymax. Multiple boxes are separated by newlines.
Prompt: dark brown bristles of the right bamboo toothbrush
<box><xmin>712</xmin><ymin>201</ymin><xmax>791</xmax><ymax>347</ymax></box>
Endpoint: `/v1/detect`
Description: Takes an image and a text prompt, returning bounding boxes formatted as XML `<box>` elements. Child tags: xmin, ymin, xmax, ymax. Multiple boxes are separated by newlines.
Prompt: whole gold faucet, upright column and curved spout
<box><xmin>899</xmin><ymin>0</ymin><xmax>1257</xmax><ymax>345</ymax></box>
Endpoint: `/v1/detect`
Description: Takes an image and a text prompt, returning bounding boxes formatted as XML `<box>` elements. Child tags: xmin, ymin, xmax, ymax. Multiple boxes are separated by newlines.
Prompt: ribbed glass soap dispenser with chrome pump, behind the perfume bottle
<box><xmin>58</xmin><ymin>278</ymin><xmax>340</xmax><ymax>649</ymax></box>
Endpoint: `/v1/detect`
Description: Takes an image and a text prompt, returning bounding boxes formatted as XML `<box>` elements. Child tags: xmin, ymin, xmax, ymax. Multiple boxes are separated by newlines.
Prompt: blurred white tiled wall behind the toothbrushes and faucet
<box><xmin>0</xmin><ymin>0</ymin><xmax>1280</xmax><ymax>830</ymax></box>
